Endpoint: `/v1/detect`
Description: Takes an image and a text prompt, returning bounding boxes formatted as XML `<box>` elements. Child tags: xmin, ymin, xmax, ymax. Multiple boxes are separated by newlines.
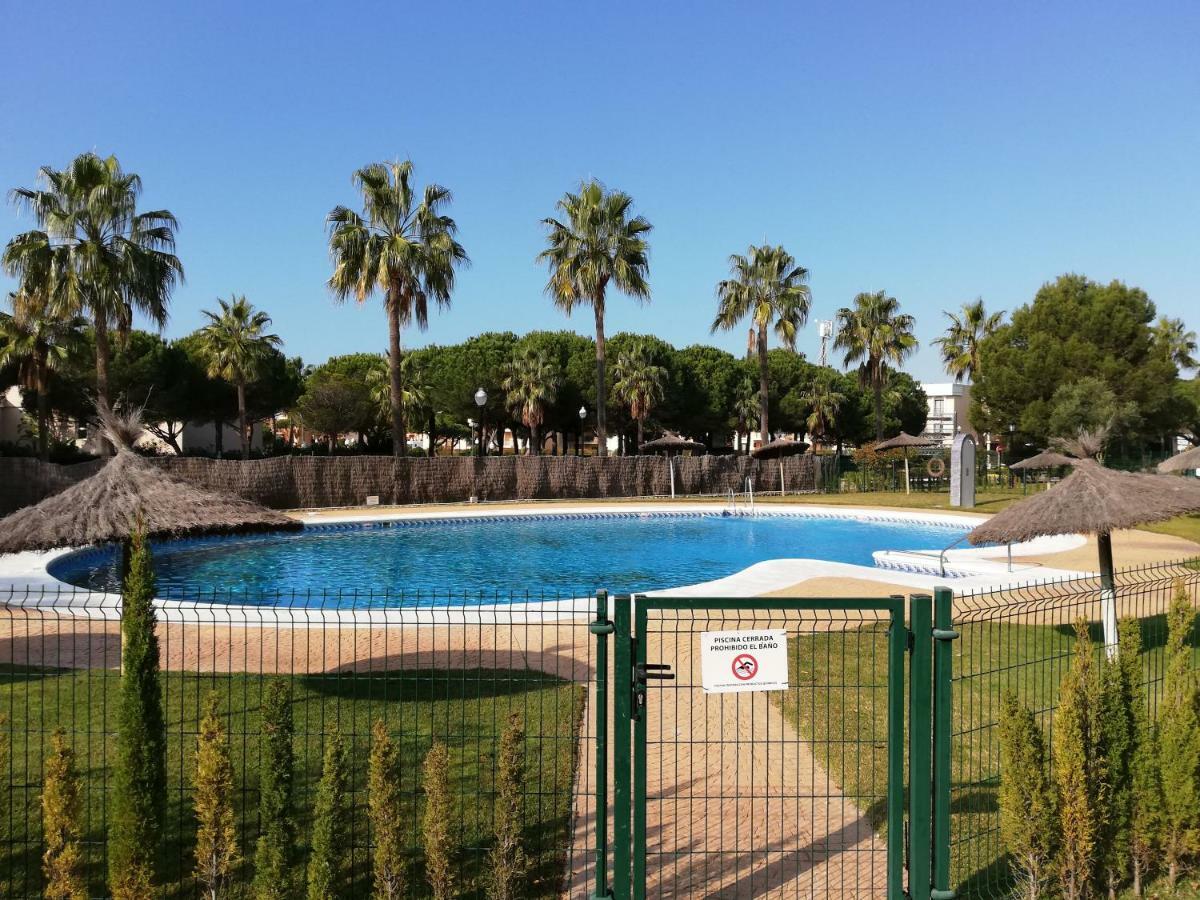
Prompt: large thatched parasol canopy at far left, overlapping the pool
<box><xmin>0</xmin><ymin>408</ymin><xmax>302</xmax><ymax>553</ymax></box>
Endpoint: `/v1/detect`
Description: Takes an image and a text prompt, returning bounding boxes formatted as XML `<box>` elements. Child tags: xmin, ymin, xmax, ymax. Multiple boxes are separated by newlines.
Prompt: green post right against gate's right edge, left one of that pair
<box><xmin>908</xmin><ymin>594</ymin><xmax>934</xmax><ymax>900</ymax></box>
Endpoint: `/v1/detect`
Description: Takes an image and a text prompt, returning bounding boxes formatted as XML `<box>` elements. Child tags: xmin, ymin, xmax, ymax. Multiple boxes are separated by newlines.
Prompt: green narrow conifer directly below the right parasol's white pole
<box><xmin>1098</xmin><ymin>619</ymin><xmax>1141</xmax><ymax>900</ymax></box>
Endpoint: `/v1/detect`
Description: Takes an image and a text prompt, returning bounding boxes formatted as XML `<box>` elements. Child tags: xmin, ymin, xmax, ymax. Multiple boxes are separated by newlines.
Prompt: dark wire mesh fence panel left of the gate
<box><xmin>0</xmin><ymin>590</ymin><xmax>596</xmax><ymax>900</ymax></box>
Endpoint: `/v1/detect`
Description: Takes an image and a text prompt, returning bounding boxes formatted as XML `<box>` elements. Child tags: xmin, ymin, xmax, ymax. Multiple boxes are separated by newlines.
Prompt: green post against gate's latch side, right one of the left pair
<box><xmin>612</xmin><ymin>594</ymin><xmax>634</xmax><ymax>900</ymax></box>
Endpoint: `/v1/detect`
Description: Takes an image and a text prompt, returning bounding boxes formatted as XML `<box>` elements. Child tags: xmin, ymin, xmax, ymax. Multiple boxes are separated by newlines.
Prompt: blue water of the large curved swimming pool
<box><xmin>50</xmin><ymin>514</ymin><xmax>965</xmax><ymax>606</ymax></box>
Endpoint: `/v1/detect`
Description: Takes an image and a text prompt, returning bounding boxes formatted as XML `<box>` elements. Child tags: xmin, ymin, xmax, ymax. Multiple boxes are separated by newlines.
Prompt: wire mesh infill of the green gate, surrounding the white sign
<box><xmin>634</xmin><ymin>598</ymin><xmax>904</xmax><ymax>898</ymax></box>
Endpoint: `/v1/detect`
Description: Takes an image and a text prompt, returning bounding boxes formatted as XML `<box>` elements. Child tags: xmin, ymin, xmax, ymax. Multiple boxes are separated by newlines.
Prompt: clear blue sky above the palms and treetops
<box><xmin>0</xmin><ymin>0</ymin><xmax>1200</xmax><ymax>379</ymax></box>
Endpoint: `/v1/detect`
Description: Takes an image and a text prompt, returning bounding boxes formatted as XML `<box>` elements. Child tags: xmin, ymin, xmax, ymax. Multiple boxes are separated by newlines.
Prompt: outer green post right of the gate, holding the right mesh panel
<box><xmin>929</xmin><ymin>588</ymin><xmax>959</xmax><ymax>900</ymax></box>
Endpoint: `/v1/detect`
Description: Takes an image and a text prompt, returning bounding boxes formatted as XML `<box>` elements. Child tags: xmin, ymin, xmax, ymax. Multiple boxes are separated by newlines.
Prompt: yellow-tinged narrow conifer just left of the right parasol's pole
<box><xmin>1054</xmin><ymin>622</ymin><xmax>1103</xmax><ymax>900</ymax></box>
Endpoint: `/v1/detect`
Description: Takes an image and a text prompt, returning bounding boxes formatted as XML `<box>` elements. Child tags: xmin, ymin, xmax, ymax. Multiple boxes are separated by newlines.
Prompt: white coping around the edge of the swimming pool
<box><xmin>0</xmin><ymin>503</ymin><xmax>1090</xmax><ymax>628</ymax></box>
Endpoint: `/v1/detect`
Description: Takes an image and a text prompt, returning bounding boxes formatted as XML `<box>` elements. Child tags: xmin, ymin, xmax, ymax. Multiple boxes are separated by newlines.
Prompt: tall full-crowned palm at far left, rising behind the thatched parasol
<box><xmin>2</xmin><ymin>152</ymin><xmax>184</xmax><ymax>451</ymax></box>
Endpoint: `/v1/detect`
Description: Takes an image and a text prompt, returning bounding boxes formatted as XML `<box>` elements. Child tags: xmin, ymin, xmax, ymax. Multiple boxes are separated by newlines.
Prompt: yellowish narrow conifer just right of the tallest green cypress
<box><xmin>194</xmin><ymin>694</ymin><xmax>238</xmax><ymax>900</ymax></box>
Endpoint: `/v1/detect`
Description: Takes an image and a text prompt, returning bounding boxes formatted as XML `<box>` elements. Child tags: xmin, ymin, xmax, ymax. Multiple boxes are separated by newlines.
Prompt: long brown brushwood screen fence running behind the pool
<box><xmin>0</xmin><ymin>456</ymin><xmax>820</xmax><ymax>514</ymax></box>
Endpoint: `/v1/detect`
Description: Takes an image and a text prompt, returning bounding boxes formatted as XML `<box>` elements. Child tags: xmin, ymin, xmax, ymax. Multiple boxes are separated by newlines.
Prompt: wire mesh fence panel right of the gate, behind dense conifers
<box><xmin>950</xmin><ymin>560</ymin><xmax>1200</xmax><ymax>898</ymax></box>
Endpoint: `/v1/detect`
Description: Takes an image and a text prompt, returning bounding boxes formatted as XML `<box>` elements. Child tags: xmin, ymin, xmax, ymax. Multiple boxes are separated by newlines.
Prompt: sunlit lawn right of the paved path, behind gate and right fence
<box><xmin>773</xmin><ymin>616</ymin><xmax>1200</xmax><ymax>898</ymax></box>
